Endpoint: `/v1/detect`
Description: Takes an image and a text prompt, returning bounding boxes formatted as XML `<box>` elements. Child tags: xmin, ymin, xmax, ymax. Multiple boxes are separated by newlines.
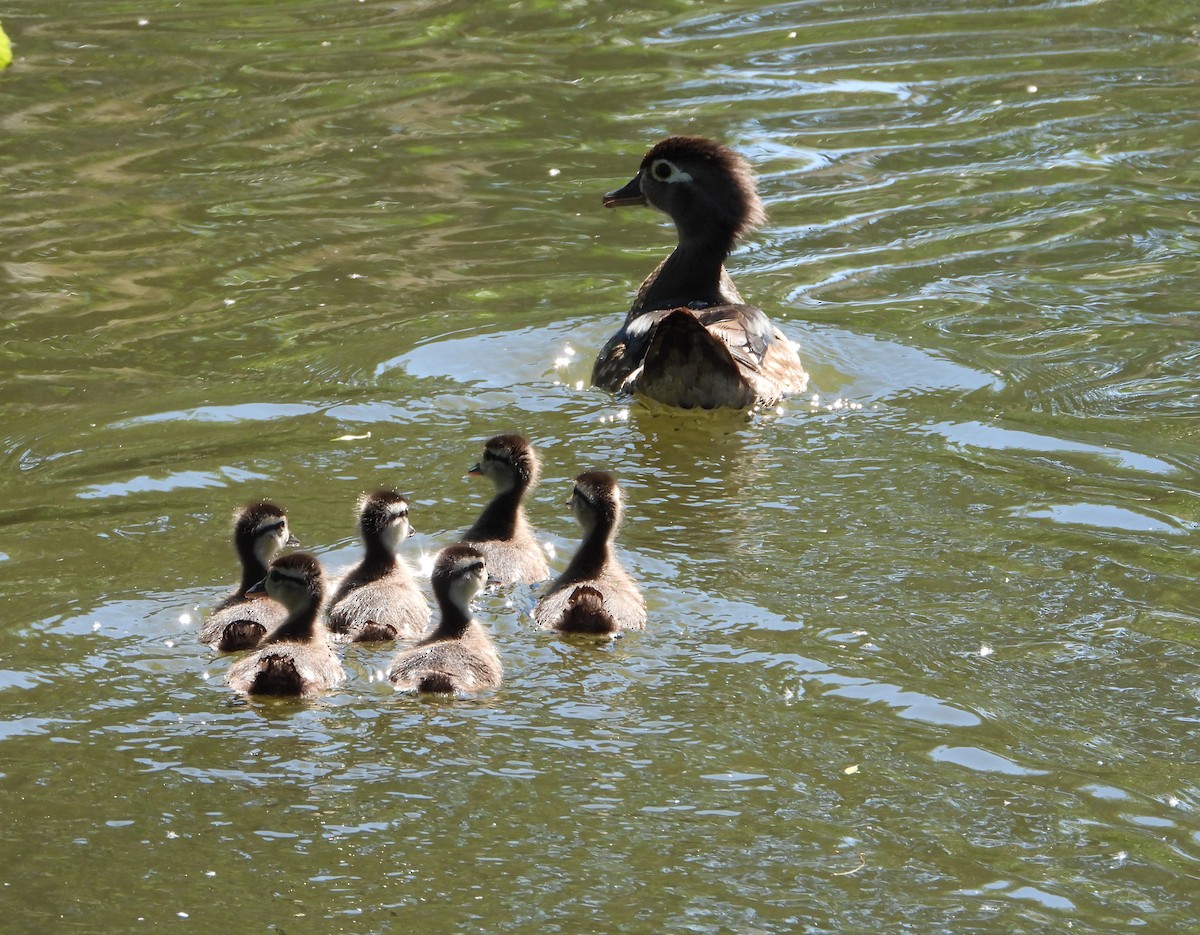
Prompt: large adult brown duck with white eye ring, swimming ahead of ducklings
<box><xmin>592</xmin><ymin>137</ymin><xmax>808</xmax><ymax>409</ymax></box>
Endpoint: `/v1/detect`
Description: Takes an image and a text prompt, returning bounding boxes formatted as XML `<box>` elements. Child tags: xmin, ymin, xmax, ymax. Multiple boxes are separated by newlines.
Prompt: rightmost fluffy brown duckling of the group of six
<box><xmin>533</xmin><ymin>471</ymin><xmax>646</xmax><ymax>636</ymax></box>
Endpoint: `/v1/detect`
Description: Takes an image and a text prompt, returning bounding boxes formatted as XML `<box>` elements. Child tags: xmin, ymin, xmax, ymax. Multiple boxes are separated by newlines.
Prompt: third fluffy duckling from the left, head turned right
<box><xmin>328</xmin><ymin>490</ymin><xmax>430</xmax><ymax>642</ymax></box>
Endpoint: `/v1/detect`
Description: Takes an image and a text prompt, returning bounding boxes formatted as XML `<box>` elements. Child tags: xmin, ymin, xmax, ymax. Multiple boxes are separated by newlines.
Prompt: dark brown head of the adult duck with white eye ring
<box><xmin>604</xmin><ymin>137</ymin><xmax>767</xmax><ymax>247</ymax></box>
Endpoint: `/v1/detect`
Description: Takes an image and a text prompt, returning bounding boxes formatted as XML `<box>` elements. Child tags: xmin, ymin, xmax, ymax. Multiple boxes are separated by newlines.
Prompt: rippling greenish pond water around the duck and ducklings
<box><xmin>0</xmin><ymin>0</ymin><xmax>1200</xmax><ymax>935</ymax></box>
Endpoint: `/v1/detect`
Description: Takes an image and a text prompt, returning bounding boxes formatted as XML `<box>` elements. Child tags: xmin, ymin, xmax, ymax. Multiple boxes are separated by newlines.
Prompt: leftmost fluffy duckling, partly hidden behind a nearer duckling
<box><xmin>200</xmin><ymin>501</ymin><xmax>300</xmax><ymax>653</ymax></box>
